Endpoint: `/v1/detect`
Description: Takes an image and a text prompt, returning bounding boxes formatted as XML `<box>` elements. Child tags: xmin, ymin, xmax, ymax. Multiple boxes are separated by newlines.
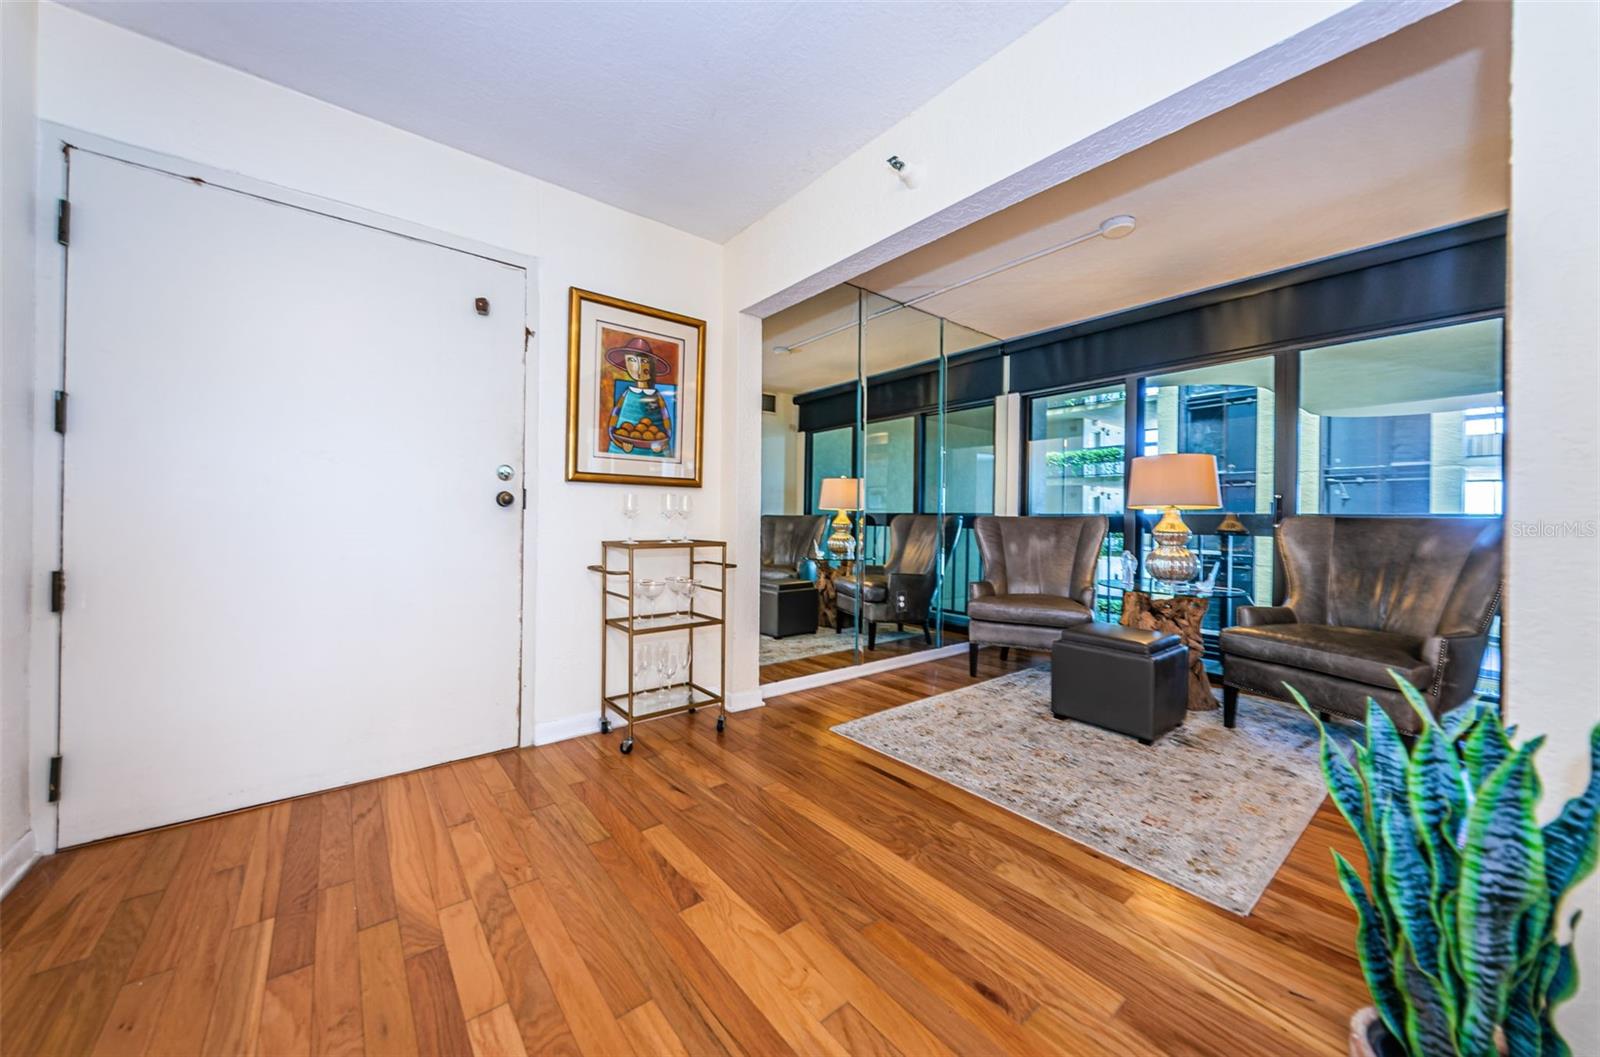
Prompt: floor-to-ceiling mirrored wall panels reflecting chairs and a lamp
<box><xmin>760</xmin><ymin>286</ymin><xmax>1002</xmax><ymax>683</ymax></box>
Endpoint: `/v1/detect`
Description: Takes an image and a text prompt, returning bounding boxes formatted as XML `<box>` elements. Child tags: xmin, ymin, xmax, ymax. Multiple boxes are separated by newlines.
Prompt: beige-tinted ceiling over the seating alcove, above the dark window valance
<box><xmin>853</xmin><ymin>3</ymin><xmax>1510</xmax><ymax>337</ymax></box>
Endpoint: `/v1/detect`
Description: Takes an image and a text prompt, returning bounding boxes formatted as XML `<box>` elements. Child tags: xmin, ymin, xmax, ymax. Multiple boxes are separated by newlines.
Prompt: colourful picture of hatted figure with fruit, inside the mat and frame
<box><xmin>598</xmin><ymin>326</ymin><xmax>683</xmax><ymax>461</ymax></box>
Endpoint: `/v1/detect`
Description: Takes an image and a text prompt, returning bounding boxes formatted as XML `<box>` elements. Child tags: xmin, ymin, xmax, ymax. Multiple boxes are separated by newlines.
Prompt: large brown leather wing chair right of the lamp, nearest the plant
<box><xmin>1221</xmin><ymin>517</ymin><xmax>1501</xmax><ymax>736</ymax></box>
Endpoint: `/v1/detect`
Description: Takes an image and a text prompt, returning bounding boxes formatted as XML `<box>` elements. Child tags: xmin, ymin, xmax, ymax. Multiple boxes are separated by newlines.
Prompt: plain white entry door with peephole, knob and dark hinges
<box><xmin>59</xmin><ymin>150</ymin><xmax>526</xmax><ymax>844</ymax></box>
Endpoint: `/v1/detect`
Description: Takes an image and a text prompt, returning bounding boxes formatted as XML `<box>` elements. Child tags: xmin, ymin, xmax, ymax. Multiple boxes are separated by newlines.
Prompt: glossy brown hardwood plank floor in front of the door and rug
<box><xmin>0</xmin><ymin>651</ymin><xmax>1366</xmax><ymax>1057</ymax></box>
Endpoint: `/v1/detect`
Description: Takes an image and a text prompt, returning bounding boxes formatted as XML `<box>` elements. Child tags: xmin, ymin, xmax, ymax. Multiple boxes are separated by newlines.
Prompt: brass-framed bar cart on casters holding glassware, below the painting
<box><xmin>589</xmin><ymin>539</ymin><xmax>736</xmax><ymax>755</ymax></box>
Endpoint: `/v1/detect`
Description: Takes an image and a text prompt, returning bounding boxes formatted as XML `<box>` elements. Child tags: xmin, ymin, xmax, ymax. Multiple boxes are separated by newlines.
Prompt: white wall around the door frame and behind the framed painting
<box><xmin>20</xmin><ymin>3</ymin><xmax>738</xmax><ymax>844</ymax></box>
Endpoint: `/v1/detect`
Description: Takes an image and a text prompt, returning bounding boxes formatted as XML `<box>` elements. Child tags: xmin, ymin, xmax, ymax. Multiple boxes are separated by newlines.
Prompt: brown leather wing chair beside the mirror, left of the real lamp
<box><xmin>966</xmin><ymin>517</ymin><xmax>1109</xmax><ymax>675</ymax></box>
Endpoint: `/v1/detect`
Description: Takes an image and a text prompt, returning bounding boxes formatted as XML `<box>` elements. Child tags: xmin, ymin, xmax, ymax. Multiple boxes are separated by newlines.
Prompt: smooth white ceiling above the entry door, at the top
<box><xmin>67</xmin><ymin>0</ymin><xmax>1062</xmax><ymax>241</ymax></box>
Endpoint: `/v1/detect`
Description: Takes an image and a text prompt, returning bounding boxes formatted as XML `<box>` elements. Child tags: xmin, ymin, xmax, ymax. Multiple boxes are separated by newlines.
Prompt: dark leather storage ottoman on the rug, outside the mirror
<box><xmin>1050</xmin><ymin>624</ymin><xmax>1189</xmax><ymax>745</ymax></box>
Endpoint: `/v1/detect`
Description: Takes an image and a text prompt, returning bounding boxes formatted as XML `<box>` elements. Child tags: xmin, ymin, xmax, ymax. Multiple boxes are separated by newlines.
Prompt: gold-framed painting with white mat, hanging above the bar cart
<box><xmin>566</xmin><ymin>286</ymin><xmax>706</xmax><ymax>488</ymax></box>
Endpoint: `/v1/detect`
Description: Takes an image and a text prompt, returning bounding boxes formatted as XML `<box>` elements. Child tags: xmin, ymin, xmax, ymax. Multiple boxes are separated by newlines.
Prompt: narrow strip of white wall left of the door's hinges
<box><xmin>0</xmin><ymin>3</ymin><xmax>37</xmax><ymax>891</ymax></box>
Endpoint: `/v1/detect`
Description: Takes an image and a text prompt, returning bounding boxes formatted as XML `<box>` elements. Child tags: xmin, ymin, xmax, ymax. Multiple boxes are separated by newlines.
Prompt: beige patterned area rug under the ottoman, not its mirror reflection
<box><xmin>834</xmin><ymin>668</ymin><xmax>1326</xmax><ymax>915</ymax></box>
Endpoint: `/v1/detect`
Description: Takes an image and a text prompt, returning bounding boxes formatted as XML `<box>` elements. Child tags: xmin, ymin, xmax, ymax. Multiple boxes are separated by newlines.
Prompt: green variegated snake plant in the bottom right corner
<box><xmin>1291</xmin><ymin>680</ymin><xmax>1600</xmax><ymax>1057</ymax></box>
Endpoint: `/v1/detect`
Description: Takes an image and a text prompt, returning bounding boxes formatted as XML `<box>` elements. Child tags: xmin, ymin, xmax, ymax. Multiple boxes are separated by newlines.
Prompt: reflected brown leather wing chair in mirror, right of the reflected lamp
<box><xmin>834</xmin><ymin>513</ymin><xmax>960</xmax><ymax>649</ymax></box>
